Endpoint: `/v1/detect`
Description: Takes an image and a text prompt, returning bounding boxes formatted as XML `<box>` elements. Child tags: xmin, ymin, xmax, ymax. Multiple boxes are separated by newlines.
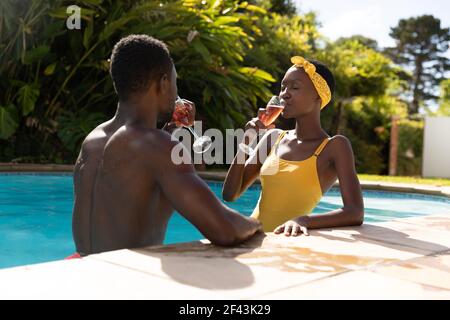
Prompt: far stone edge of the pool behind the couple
<box><xmin>0</xmin><ymin>163</ymin><xmax>450</xmax><ymax>198</ymax></box>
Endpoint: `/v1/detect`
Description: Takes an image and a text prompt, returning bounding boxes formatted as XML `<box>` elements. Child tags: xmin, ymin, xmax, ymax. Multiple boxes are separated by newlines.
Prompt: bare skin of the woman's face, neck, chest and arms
<box><xmin>222</xmin><ymin>67</ymin><xmax>364</xmax><ymax>236</ymax></box>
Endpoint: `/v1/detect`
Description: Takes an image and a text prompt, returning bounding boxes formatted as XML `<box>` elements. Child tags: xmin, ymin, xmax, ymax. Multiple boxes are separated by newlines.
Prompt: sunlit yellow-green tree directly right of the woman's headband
<box><xmin>316</xmin><ymin>39</ymin><xmax>406</xmax><ymax>174</ymax></box>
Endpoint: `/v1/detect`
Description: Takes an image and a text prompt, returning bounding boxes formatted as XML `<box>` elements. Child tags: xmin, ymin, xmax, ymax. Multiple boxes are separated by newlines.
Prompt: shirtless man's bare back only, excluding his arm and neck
<box><xmin>73</xmin><ymin>121</ymin><xmax>173</xmax><ymax>253</ymax></box>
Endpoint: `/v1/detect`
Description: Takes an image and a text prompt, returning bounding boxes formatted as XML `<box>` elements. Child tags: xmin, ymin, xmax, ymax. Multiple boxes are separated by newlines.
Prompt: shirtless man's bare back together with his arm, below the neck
<box><xmin>73</xmin><ymin>120</ymin><xmax>260</xmax><ymax>255</ymax></box>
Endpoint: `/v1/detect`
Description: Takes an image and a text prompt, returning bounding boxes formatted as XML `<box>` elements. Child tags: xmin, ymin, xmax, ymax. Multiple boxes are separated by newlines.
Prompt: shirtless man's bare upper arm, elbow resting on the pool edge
<box><xmin>150</xmin><ymin>135</ymin><xmax>260</xmax><ymax>245</ymax></box>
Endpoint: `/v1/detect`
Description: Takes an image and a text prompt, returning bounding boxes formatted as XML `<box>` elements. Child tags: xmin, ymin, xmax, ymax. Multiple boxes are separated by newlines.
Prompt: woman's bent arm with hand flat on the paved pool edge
<box><xmin>274</xmin><ymin>136</ymin><xmax>364</xmax><ymax>236</ymax></box>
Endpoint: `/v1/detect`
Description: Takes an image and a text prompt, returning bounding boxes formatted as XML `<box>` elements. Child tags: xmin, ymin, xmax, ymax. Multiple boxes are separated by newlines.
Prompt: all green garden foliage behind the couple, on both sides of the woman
<box><xmin>0</xmin><ymin>0</ymin><xmax>436</xmax><ymax>178</ymax></box>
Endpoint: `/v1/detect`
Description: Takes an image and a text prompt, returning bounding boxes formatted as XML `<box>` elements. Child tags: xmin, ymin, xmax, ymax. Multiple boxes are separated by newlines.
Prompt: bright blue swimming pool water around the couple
<box><xmin>0</xmin><ymin>174</ymin><xmax>450</xmax><ymax>268</ymax></box>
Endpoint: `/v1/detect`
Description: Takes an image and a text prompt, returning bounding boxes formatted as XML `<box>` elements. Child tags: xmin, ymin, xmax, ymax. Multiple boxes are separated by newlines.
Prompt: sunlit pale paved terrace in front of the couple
<box><xmin>0</xmin><ymin>214</ymin><xmax>450</xmax><ymax>299</ymax></box>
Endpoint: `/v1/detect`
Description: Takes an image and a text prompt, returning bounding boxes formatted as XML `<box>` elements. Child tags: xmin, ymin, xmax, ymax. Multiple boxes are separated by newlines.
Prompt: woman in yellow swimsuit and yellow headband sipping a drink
<box><xmin>222</xmin><ymin>56</ymin><xmax>364</xmax><ymax>236</ymax></box>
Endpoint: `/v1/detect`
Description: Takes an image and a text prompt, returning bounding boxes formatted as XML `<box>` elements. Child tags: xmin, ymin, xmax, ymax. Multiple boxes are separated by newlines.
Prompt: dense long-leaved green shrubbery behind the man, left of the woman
<box><xmin>0</xmin><ymin>0</ymin><xmax>274</xmax><ymax>162</ymax></box>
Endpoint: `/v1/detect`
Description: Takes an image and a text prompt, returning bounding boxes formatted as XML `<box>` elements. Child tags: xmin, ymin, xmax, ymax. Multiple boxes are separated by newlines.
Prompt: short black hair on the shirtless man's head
<box><xmin>110</xmin><ymin>34</ymin><xmax>173</xmax><ymax>101</ymax></box>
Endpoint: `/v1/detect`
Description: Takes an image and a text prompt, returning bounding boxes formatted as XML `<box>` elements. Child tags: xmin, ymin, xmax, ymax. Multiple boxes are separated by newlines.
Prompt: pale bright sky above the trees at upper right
<box><xmin>293</xmin><ymin>0</ymin><xmax>450</xmax><ymax>48</ymax></box>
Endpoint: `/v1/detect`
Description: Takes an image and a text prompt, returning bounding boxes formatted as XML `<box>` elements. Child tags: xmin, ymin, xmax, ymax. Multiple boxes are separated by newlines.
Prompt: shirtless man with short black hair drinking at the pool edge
<box><xmin>73</xmin><ymin>35</ymin><xmax>260</xmax><ymax>255</ymax></box>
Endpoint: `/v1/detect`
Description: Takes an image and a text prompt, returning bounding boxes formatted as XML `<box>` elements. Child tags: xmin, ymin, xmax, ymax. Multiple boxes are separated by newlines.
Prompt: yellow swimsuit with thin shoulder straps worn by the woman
<box><xmin>252</xmin><ymin>131</ymin><xmax>330</xmax><ymax>232</ymax></box>
